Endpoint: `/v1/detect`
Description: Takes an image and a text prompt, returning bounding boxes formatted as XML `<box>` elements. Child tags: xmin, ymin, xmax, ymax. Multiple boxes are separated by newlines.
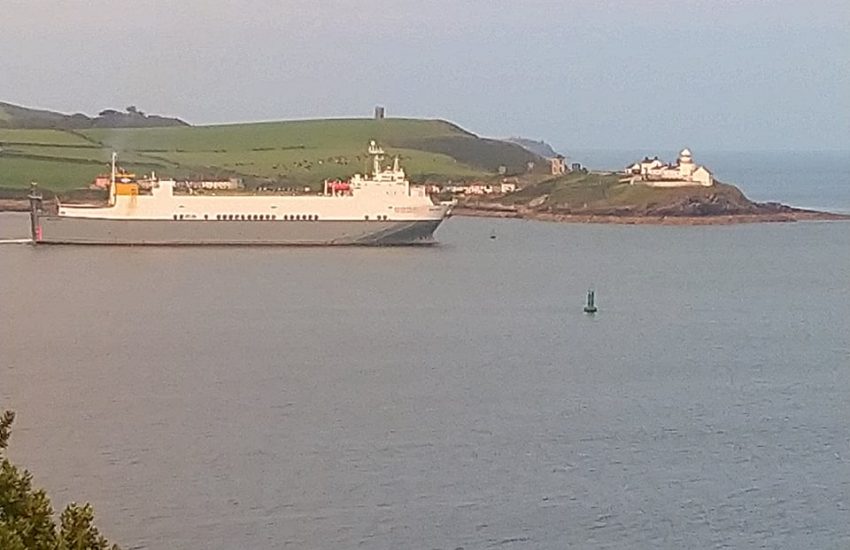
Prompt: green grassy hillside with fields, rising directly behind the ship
<box><xmin>0</xmin><ymin>119</ymin><xmax>541</xmax><ymax>191</ymax></box>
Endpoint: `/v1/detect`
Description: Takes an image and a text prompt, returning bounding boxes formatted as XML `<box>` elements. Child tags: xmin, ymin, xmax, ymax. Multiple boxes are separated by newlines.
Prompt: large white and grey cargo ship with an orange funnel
<box><xmin>30</xmin><ymin>141</ymin><xmax>452</xmax><ymax>245</ymax></box>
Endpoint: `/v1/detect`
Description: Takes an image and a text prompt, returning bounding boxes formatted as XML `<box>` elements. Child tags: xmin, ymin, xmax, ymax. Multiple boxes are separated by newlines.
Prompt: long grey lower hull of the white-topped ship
<box><xmin>38</xmin><ymin>216</ymin><xmax>442</xmax><ymax>246</ymax></box>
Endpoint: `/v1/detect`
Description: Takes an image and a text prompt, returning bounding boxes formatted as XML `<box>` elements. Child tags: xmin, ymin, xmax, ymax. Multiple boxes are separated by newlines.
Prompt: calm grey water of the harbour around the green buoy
<box><xmin>0</xmin><ymin>215</ymin><xmax>850</xmax><ymax>550</ymax></box>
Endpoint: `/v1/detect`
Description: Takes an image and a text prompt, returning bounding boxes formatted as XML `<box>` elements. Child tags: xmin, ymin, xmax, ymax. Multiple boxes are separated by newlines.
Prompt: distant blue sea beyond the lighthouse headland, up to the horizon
<box><xmin>570</xmin><ymin>150</ymin><xmax>850</xmax><ymax>213</ymax></box>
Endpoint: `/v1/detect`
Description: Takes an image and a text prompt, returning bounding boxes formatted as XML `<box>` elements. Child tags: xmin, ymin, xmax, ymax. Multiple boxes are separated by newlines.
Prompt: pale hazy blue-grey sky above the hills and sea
<box><xmin>0</xmin><ymin>0</ymin><xmax>850</xmax><ymax>150</ymax></box>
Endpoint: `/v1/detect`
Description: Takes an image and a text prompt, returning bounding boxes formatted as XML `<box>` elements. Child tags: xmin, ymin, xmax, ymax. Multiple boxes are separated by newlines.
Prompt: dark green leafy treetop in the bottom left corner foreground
<box><xmin>0</xmin><ymin>411</ymin><xmax>118</xmax><ymax>550</ymax></box>
